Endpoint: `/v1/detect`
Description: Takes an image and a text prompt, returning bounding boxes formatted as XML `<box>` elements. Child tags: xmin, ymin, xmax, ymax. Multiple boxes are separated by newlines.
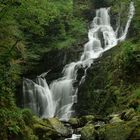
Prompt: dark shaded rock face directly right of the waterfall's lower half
<box><xmin>76</xmin><ymin>48</ymin><xmax>116</xmax><ymax>115</ymax></box>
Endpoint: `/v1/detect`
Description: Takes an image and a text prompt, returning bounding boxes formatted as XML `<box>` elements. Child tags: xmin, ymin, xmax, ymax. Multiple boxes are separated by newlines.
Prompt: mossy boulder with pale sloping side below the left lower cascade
<box><xmin>33</xmin><ymin>117</ymin><xmax>71</xmax><ymax>140</ymax></box>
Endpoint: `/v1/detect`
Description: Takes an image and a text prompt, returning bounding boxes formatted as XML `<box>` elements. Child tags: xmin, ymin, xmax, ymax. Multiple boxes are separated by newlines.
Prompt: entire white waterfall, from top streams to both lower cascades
<box><xmin>23</xmin><ymin>2</ymin><xmax>135</xmax><ymax>121</ymax></box>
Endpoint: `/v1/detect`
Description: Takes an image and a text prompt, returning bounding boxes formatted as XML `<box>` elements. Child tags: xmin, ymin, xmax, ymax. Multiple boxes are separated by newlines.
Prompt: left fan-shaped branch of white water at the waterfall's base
<box><xmin>23</xmin><ymin>77</ymin><xmax>54</xmax><ymax>118</ymax></box>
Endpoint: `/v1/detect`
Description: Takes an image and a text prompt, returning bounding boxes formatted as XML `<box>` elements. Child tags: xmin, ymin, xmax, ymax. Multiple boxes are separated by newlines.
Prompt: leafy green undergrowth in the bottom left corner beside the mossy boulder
<box><xmin>0</xmin><ymin>108</ymin><xmax>38</xmax><ymax>140</ymax></box>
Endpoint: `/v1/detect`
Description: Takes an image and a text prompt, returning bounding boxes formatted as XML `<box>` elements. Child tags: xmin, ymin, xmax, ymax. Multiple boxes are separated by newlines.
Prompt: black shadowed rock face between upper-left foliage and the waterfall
<box><xmin>24</xmin><ymin>43</ymin><xmax>86</xmax><ymax>83</ymax></box>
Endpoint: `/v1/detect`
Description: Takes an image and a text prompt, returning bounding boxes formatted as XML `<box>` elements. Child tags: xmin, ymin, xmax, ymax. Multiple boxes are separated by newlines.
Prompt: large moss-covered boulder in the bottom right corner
<box><xmin>99</xmin><ymin>121</ymin><xmax>140</xmax><ymax>140</ymax></box>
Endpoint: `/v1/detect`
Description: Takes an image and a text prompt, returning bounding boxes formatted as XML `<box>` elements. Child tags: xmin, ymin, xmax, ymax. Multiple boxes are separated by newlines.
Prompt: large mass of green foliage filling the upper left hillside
<box><xmin>0</xmin><ymin>0</ymin><xmax>86</xmax><ymax>106</ymax></box>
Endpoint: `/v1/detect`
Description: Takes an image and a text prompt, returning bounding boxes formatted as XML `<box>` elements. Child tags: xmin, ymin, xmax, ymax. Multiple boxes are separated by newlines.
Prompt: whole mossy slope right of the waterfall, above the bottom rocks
<box><xmin>77</xmin><ymin>41</ymin><xmax>140</xmax><ymax>116</ymax></box>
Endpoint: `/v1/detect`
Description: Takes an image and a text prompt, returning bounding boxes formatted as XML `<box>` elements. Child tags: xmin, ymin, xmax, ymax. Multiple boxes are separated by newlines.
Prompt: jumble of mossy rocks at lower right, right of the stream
<box><xmin>66</xmin><ymin>109</ymin><xmax>140</xmax><ymax>140</ymax></box>
